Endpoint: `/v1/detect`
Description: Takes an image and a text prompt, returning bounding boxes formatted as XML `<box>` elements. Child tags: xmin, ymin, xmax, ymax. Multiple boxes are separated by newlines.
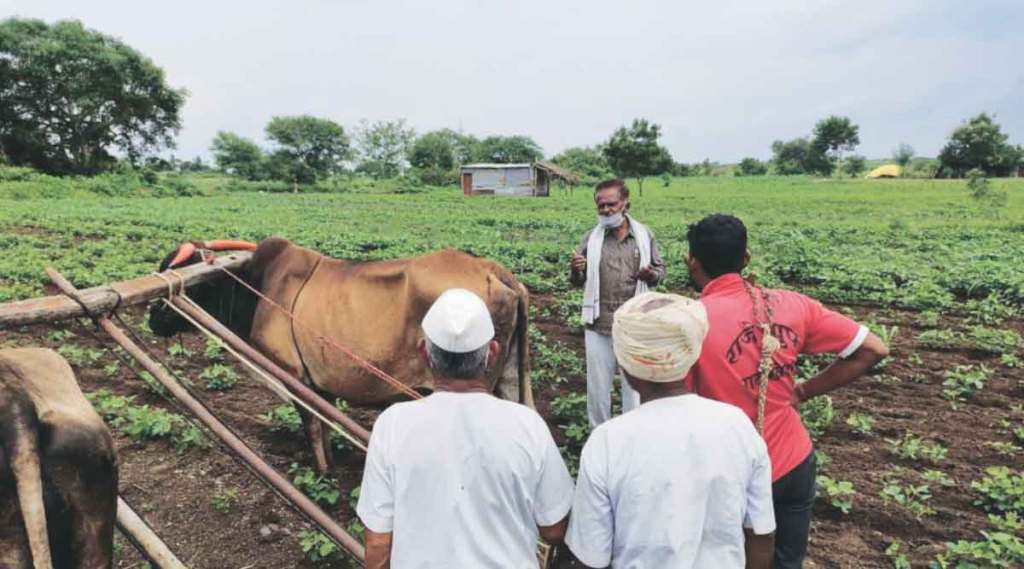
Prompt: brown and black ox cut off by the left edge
<box><xmin>0</xmin><ymin>348</ymin><xmax>118</xmax><ymax>569</ymax></box>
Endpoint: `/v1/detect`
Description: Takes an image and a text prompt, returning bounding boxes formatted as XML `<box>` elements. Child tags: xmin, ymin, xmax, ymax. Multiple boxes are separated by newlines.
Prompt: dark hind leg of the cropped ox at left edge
<box><xmin>44</xmin><ymin>425</ymin><xmax>118</xmax><ymax>569</ymax></box>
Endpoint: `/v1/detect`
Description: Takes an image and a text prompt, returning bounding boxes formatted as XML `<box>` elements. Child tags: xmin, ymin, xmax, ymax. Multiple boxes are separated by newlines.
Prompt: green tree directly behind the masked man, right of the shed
<box><xmin>603</xmin><ymin>119</ymin><xmax>675</xmax><ymax>195</ymax></box>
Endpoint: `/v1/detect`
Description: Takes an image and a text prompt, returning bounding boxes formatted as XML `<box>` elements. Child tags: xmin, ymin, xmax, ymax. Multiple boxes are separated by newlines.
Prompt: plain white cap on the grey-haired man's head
<box><xmin>423</xmin><ymin>289</ymin><xmax>495</xmax><ymax>354</ymax></box>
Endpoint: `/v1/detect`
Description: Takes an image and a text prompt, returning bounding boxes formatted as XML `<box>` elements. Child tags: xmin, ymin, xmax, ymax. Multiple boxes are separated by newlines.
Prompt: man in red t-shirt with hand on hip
<box><xmin>686</xmin><ymin>215</ymin><xmax>889</xmax><ymax>569</ymax></box>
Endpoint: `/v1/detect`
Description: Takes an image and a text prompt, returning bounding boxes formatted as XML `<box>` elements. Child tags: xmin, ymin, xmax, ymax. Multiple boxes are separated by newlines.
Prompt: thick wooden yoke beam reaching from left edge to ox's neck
<box><xmin>0</xmin><ymin>251</ymin><xmax>252</xmax><ymax>330</ymax></box>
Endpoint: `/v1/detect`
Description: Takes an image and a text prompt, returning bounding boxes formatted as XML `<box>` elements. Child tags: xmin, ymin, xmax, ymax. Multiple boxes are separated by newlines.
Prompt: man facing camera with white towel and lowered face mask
<box><xmin>569</xmin><ymin>179</ymin><xmax>665</xmax><ymax>428</ymax></box>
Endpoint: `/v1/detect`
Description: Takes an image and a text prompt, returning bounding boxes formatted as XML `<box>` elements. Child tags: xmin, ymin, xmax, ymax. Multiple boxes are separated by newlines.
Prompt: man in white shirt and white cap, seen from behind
<box><xmin>356</xmin><ymin>289</ymin><xmax>572</xmax><ymax>569</ymax></box>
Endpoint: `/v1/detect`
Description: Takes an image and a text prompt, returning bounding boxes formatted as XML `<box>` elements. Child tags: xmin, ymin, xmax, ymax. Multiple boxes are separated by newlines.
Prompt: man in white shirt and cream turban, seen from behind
<box><xmin>566</xmin><ymin>293</ymin><xmax>775</xmax><ymax>569</ymax></box>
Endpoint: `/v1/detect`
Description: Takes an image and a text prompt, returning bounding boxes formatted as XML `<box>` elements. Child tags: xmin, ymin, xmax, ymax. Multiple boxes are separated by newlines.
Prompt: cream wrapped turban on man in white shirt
<box><xmin>611</xmin><ymin>293</ymin><xmax>708</xmax><ymax>383</ymax></box>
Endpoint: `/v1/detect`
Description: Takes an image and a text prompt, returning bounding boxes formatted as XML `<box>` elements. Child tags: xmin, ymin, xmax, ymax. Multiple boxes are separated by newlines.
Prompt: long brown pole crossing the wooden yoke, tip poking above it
<box><xmin>46</xmin><ymin>268</ymin><xmax>366</xmax><ymax>562</ymax></box>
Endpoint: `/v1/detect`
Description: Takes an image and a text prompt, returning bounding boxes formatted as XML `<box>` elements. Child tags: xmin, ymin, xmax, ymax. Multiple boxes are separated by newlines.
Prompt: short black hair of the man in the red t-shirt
<box><xmin>686</xmin><ymin>214</ymin><xmax>746</xmax><ymax>278</ymax></box>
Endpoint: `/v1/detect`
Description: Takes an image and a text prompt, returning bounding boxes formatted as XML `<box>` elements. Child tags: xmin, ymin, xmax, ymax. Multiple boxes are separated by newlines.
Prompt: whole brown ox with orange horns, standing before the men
<box><xmin>150</xmin><ymin>237</ymin><xmax>534</xmax><ymax>472</ymax></box>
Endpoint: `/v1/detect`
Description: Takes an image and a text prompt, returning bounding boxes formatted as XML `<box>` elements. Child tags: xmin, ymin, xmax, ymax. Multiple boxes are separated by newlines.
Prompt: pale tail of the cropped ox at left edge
<box><xmin>0</xmin><ymin>381</ymin><xmax>53</xmax><ymax>569</ymax></box>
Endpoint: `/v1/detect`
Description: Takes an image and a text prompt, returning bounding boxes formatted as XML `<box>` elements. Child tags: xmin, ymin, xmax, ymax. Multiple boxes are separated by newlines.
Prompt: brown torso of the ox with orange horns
<box><xmin>251</xmin><ymin>239</ymin><xmax>527</xmax><ymax>404</ymax></box>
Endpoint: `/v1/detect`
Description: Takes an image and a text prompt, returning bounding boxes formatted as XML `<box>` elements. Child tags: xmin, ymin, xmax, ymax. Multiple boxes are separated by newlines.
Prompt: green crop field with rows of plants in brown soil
<box><xmin>0</xmin><ymin>176</ymin><xmax>1024</xmax><ymax>567</ymax></box>
